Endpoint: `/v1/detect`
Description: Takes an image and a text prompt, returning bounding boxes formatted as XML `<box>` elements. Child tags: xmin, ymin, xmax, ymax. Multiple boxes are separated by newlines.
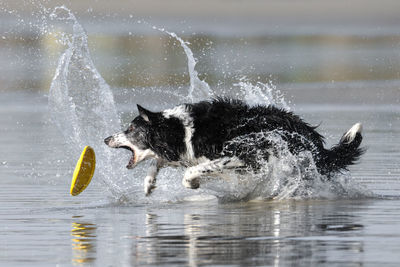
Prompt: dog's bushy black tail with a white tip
<box><xmin>322</xmin><ymin>123</ymin><xmax>365</xmax><ymax>175</ymax></box>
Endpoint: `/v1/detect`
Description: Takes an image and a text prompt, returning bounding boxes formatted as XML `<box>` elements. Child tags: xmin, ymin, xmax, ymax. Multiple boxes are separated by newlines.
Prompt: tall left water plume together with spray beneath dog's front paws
<box><xmin>48</xmin><ymin>6</ymin><xmax>203</xmax><ymax>203</ymax></box>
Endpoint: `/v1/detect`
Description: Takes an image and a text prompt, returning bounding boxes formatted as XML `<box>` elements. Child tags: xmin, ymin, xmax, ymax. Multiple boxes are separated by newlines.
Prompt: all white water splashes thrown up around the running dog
<box><xmin>44</xmin><ymin>7</ymin><xmax>363</xmax><ymax>203</ymax></box>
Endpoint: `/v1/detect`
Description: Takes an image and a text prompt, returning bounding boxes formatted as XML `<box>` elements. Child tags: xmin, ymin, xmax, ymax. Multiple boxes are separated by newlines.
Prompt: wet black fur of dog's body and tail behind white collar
<box><xmin>187</xmin><ymin>98</ymin><xmax>363</xmax><ymax>175</ymax></box>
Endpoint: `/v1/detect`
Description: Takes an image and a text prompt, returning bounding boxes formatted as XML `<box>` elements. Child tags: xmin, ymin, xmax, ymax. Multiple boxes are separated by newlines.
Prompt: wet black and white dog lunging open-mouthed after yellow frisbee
<box><xmin>104</xmin><ymin>98</ymin><xmax>364</xmax><ymax>195</ymax></box>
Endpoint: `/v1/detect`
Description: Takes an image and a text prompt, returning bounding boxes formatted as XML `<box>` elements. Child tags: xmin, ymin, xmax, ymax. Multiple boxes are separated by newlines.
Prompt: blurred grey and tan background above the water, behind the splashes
<box><xmin>0</xmin><ymin>0</ymin><xmax>400</xmax><ymax>104</ymax></box>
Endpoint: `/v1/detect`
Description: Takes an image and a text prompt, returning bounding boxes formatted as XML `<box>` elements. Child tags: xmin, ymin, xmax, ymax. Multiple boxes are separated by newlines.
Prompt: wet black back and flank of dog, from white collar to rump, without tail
<box><xmin>190</xmin><ymin>98</ymin><xmax>324</xmax><ymax>159</ymax></box>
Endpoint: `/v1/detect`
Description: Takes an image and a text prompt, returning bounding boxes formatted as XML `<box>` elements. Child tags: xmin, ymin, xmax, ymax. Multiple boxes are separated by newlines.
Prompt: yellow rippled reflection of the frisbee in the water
<box><xmin>71</xmin><ymin>219</ymin><xmax>97</xmax><ymax>266</ymax></box>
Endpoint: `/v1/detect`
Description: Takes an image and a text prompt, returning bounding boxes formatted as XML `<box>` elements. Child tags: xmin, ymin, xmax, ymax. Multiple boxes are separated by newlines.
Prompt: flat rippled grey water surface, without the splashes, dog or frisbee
<box><xmin>0</xmin><ymin>93</ymin><xmax>400</xmax><ymax>266</ymax></box>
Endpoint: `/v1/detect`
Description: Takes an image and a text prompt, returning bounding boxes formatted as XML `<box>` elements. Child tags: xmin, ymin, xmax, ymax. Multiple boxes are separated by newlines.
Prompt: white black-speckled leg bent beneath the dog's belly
<box><xmin>182</xmin><ymin>157</ymin><xmax>245</xmax><ymax>189</ymax></box>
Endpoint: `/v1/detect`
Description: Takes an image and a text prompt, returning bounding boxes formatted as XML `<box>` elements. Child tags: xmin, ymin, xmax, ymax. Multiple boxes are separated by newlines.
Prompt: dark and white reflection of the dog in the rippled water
<box><xmin>132</xmin><ymin>201</ymin><xmax>364</xmax><ymax>266</ymax></box>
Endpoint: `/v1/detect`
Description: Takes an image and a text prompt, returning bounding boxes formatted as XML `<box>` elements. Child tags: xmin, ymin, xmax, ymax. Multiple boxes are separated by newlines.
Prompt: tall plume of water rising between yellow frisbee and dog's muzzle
<box><xmin>48</xmin><ymin>6</ymin><xmax>130</xmax><ymax>199</ymax></box>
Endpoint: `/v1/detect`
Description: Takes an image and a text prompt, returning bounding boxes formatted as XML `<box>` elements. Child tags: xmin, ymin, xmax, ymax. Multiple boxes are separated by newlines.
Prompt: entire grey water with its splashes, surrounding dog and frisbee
<box><xmin>0</xmin><ymin>4</ymin><xmax>400</xmax><ymax>266</ymax></box>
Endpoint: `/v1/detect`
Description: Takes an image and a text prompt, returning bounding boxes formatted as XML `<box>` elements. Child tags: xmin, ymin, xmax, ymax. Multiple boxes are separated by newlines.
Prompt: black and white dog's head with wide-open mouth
<box><xmin>104</xmin><ymin>105</ymin><xmax>158</xmax><ymax>169</ymax></box>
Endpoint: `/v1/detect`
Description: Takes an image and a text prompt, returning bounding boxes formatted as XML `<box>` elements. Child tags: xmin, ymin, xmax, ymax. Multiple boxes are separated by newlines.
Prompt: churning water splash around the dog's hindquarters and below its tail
<box><xmin>206</xmin><ymin>130</ymin><xmax>371</xmax><ymax>201</ymax></box>
